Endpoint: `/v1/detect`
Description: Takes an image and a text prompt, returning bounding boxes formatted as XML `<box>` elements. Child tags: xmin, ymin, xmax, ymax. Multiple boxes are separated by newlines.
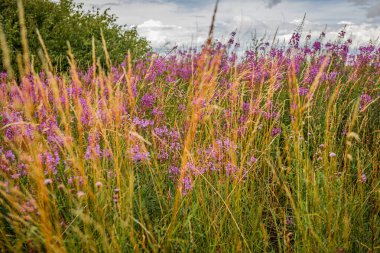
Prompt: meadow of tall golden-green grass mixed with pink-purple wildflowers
<box><xmin>0</xmin><ymin>10</ymin><xmax>380</xmax><ymax>252</ymax></box>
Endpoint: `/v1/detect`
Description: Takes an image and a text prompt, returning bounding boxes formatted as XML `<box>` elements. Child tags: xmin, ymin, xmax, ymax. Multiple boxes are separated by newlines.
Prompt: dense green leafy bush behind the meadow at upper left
<box><xmin>0</xmin><ymin>0</ymin><xmax>150</xmax><ymax>70</ymax></box>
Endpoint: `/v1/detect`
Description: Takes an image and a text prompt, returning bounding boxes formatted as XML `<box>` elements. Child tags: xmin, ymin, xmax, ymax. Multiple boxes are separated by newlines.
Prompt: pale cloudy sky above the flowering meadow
<box><xmin>75</xmin><ymin>0</ymin><xmax>380</xmax><ymax>48</ymax></box>
